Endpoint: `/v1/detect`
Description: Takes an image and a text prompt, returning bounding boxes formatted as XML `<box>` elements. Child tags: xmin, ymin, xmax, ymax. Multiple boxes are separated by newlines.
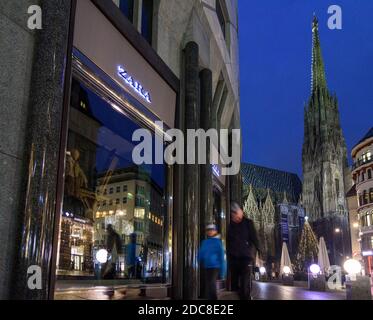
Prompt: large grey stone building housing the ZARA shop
<box><xmin>0</xmin><ymin>0</ymin><xmax>241</xmax><ymax>299</ymax></box>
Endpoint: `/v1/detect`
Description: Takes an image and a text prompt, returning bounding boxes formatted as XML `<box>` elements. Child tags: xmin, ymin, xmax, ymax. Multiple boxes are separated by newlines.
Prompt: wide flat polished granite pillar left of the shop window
<box><xmin>11</xmin><ymin>0</ymin><xmax>71</xmax><ymax>299</ymax></box>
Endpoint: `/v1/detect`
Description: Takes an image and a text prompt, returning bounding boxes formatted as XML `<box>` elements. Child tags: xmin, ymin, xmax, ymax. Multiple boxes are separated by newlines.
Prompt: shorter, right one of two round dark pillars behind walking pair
<box><xmin>200</xmin><ymin>69</ymin><xmax>212</xmax><ymax>232</ymax></box>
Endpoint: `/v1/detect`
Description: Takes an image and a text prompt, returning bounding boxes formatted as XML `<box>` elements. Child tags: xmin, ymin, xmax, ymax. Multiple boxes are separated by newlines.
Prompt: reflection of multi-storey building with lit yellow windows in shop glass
<box><xmin>94</xmin><ymin>167</ymin><xmax>165</xmax><ymax>272</ymax></box>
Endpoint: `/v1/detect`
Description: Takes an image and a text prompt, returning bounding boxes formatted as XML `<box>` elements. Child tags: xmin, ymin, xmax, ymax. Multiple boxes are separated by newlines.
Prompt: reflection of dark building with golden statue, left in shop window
<box><xmin>58</xmin><ymin>81</ymin><xmax>97</xmax><ymax>272</ymax></box>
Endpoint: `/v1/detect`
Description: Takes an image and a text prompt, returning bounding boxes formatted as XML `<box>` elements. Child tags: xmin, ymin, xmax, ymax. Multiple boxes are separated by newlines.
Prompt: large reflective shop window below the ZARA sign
<box><xmin>56</xmin><ymin>75</ymin><xmax>171</xmax><ymax>291</ymax></box>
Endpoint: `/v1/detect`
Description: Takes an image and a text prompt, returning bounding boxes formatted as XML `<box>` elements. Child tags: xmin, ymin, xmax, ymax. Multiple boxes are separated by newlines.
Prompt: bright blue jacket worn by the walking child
<box><xmin>199</xmin><ymin>236</ymin><xmax>226</xmax><ymax>278</ymax></box>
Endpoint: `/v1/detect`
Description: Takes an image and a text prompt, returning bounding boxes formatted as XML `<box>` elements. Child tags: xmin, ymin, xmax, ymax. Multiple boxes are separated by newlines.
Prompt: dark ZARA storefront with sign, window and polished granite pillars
<box><xmin>11</xmin><ymin>0</ymin><xmax>241</xmax><ymax>299</ymax></box>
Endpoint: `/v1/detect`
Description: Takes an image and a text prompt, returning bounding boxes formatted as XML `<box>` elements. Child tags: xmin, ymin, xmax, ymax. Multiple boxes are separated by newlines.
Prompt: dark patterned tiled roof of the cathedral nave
<box><xmin>241</xmin><ymin>163</ymin><xmax>302</xmax><ymax>203</ymax></box>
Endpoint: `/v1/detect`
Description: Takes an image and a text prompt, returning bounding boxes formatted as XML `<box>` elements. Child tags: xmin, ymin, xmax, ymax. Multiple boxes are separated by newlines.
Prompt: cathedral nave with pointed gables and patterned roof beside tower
<box><xmin>241</xmin><ymin>163</ymin><xmax>304</xmax><ymax>265</ymax></box>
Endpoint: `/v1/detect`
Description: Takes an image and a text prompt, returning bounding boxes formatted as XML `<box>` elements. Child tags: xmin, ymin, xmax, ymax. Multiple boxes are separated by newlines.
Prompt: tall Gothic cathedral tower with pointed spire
<box><xmin>302</xmin><ymin>17</ymin><xmax>351</xmax><ymax>265</ymax></box>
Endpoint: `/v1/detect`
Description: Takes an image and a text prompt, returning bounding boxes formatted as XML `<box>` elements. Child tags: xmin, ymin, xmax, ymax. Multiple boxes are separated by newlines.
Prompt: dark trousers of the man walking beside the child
<box><xmin>230</xmin><ymin>257</ymin><xmax>252</xmax><ymax>300</ymax></box>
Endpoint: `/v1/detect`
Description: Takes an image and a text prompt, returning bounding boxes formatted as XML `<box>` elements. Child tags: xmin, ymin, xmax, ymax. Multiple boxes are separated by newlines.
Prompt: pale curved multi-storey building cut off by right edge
<box><xmin>350</xmin><ymin>128</ymin><xmax>373</xmax><ymax>274</ymax></box>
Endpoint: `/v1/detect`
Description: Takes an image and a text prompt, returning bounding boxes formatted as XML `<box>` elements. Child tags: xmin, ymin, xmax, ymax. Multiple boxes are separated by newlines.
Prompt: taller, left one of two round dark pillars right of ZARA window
<box><xmin>183</xmin><ymin>42</ymin><xmax>200</xmax><ymax>300</ymax></box>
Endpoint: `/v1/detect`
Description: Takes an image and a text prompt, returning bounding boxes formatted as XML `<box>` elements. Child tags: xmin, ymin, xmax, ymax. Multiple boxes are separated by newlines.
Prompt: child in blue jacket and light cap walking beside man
<box><xmin>199</xmin><ymin>224</ymin><xmax>226</xmax><ymax>300</ymax></box>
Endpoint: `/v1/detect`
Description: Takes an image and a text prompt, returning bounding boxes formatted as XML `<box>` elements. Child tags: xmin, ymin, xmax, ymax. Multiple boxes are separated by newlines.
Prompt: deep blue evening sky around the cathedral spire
<box><xmin>238</xmin><ymin>0</ymin><xmax>373</xmax><ymax>176</ymax></box>
